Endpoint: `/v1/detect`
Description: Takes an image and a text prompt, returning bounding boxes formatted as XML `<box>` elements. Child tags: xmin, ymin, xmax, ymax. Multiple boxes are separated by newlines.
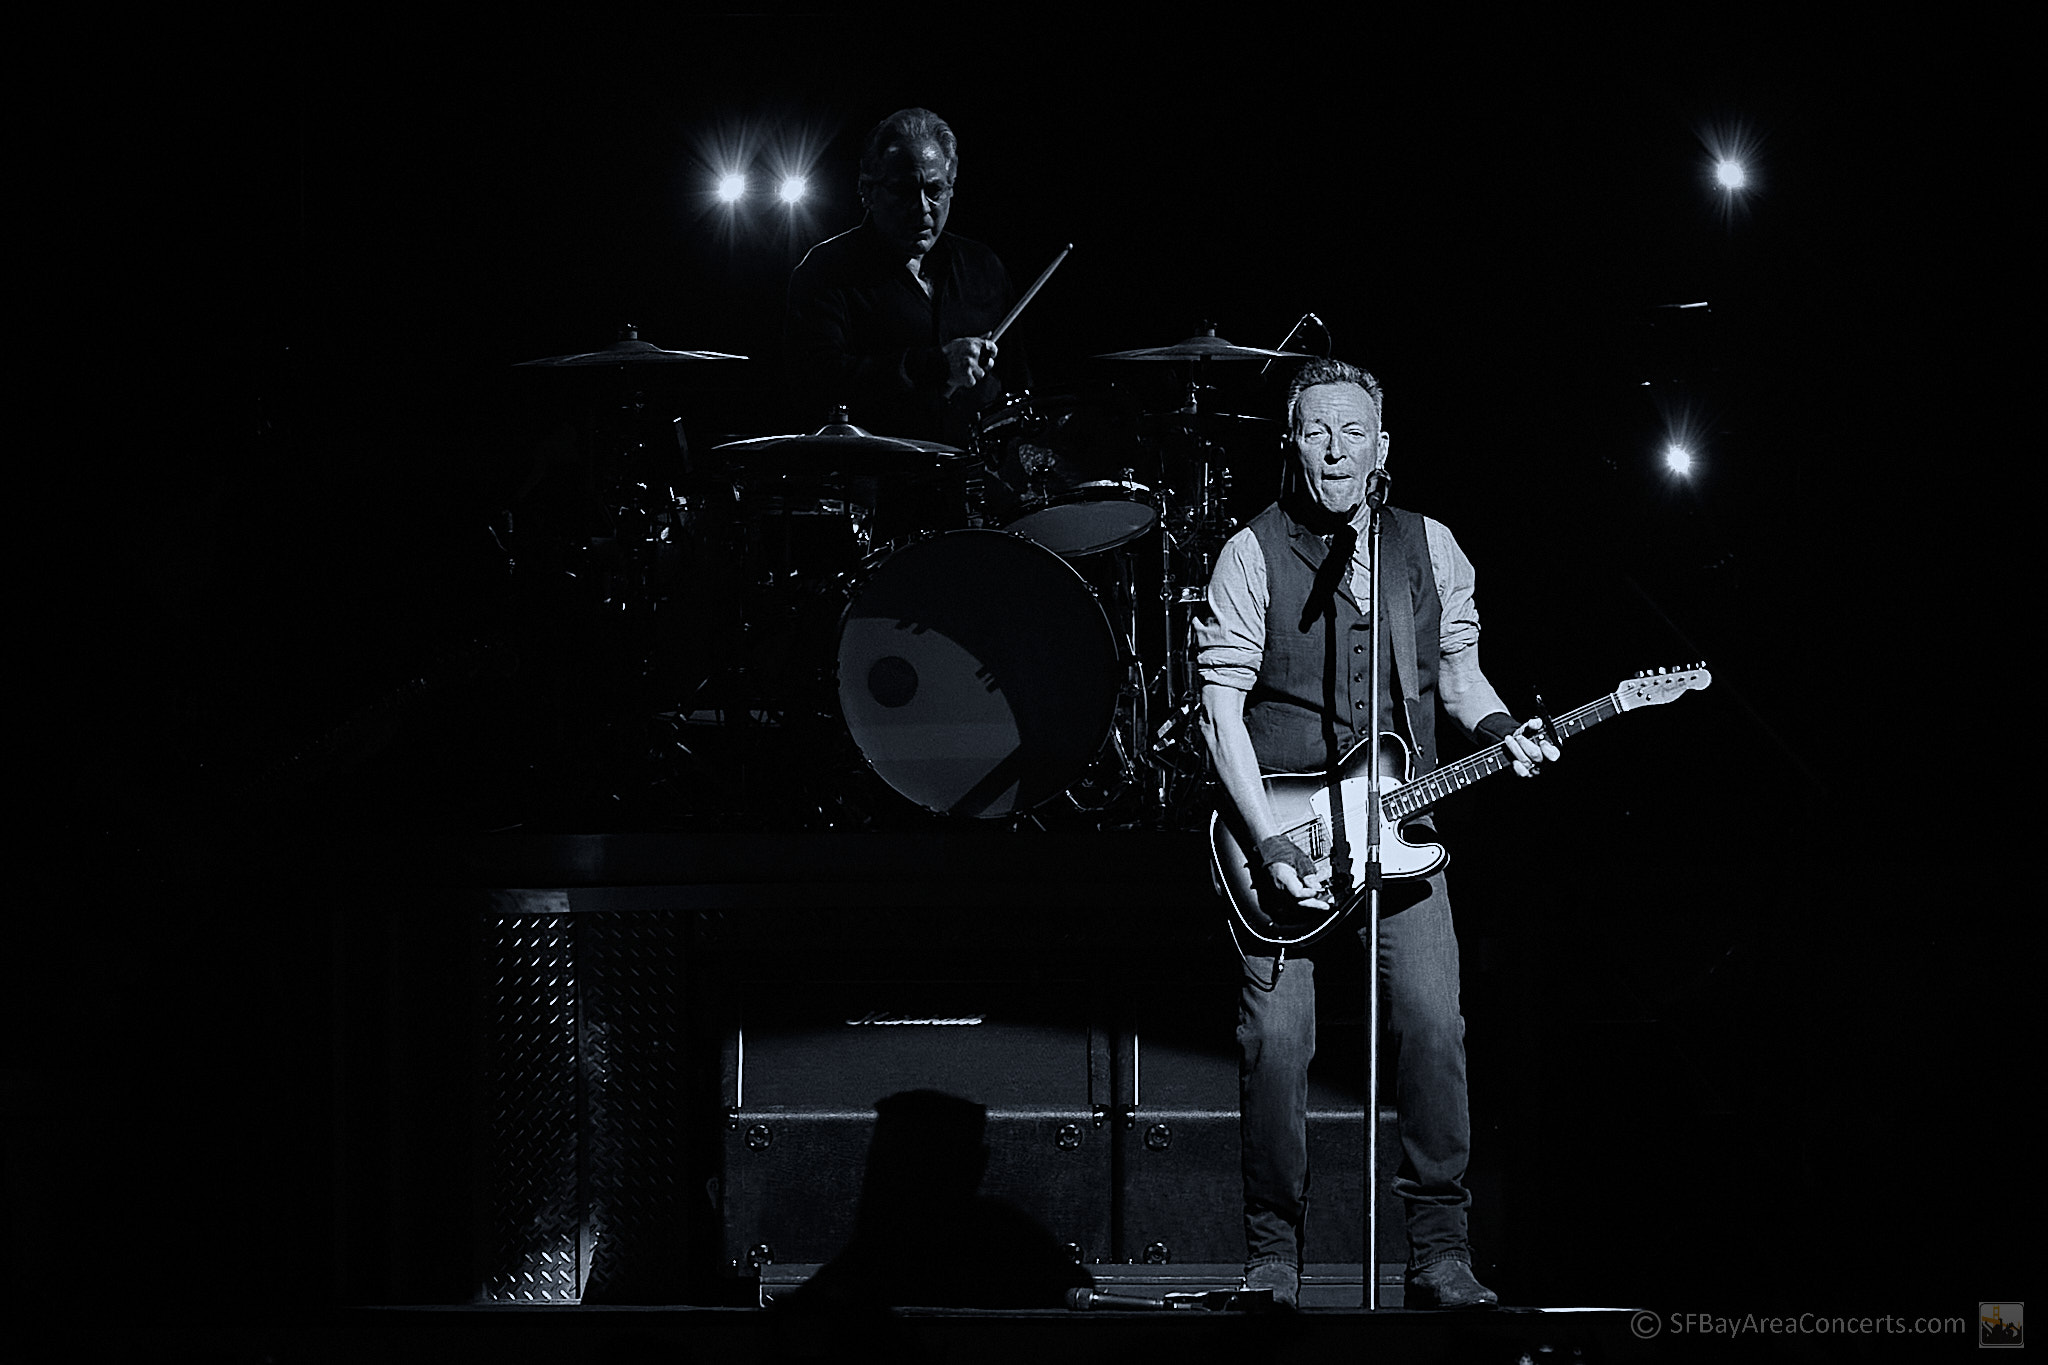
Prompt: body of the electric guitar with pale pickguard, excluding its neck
<box><xmin>1208</xmin><ymin>735</ymin><xmax>1450</xmax><ymax>948</ymax></box>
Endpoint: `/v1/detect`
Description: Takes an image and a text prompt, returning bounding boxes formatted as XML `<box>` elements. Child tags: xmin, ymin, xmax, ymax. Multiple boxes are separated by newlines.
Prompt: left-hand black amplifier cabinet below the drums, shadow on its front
<box><xmin>719</xmin><ymin>980</ymin><xmax>1112</xmax><ymax>1277</ymax></box>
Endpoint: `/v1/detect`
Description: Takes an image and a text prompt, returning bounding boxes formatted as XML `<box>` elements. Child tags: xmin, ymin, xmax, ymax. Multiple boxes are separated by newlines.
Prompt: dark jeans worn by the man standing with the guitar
<box><xmin>1237</xmin><ymin>874</ymin><xmax>1473</xmax><ymax>1273</ymax></box>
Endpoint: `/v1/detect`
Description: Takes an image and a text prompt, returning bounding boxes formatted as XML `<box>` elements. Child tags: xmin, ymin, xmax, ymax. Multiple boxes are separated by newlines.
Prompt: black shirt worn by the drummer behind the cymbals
<box><xmin>782</xmin><ymin>223</ymin><xmax>1030</xmax><ymax>446</ymax></box>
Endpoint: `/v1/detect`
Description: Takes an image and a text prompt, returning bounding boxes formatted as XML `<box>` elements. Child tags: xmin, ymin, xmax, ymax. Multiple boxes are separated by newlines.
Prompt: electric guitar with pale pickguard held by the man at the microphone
<box><xmin>1208</xmin><ymin>665</ymin><xmax>1712</xmax><ymax>948</ymax></box>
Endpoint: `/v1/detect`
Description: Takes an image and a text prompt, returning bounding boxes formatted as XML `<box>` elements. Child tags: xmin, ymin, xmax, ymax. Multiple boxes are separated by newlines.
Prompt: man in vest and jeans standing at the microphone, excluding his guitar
<box><xmin>1196</xmin><ymin>360</ymin><xmax>1559</xmax><ymax>1308</ymax></box>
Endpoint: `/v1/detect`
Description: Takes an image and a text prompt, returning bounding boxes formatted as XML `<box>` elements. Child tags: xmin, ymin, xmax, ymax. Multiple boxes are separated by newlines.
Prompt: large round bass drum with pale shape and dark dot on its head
<box><xmin>836</xmin><ymin>530</ymin><xmax>1124</xmax><ymax>819</ymax></box>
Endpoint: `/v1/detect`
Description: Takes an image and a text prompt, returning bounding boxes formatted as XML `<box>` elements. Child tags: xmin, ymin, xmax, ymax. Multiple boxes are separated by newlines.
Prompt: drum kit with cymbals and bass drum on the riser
<box><xmin>503</xmin><ymin>332</ymin><xmax>1305</xmax><ymax>827</ymax></box>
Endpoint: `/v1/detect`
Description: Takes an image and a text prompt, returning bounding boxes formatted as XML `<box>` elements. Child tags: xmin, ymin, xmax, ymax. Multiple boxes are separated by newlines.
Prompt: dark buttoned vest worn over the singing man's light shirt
<box><xmin>1245</xmin><ymin>503</ymin><xmax>1442</xmax><ymax>772</ymax></box>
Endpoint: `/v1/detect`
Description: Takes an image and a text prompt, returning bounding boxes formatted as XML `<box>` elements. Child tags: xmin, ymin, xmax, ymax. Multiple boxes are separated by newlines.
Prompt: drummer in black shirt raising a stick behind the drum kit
<box><xmin>782</xmin><ymin>108</ymin><xmax>1030</xmax><ymax>446</ymax></box>
